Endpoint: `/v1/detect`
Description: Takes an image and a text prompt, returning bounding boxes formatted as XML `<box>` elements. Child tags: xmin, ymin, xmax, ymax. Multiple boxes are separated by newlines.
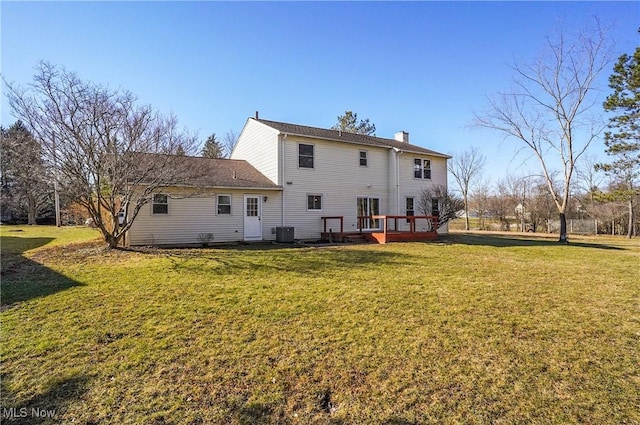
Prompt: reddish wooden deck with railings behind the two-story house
<box><xmin>321</xmin><ymin>215</ymin><xmax>438</xmax><ymax>244</ymax></box>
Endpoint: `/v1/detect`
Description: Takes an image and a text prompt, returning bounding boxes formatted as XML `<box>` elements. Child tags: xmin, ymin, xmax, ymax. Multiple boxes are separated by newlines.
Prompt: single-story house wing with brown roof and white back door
<box><xmin>125</xmin><ymin>157</ymin><xmax>282</xmax><ymax>246</ymax></box>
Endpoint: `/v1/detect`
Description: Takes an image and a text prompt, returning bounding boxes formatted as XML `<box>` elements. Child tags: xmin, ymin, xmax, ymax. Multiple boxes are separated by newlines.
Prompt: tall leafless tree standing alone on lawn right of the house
<box><xmin>475</xmin><ymin>21</ymin><xmax>612</xmax><ymax>243</ymax></box>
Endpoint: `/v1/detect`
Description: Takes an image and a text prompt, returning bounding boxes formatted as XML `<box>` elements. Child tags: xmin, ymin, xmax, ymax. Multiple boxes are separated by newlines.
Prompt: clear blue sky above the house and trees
<box><xmin>0</xmin><ymin>1</ymin><xmax>640</xmax><ymax>181</ymax></box>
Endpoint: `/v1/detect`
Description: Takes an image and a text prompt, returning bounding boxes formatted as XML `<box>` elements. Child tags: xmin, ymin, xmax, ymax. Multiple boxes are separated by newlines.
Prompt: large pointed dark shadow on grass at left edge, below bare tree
<box><xmin>0</xmin><ymin>236</ymin><xmax>81</xmax><ymax>309</ymax></box>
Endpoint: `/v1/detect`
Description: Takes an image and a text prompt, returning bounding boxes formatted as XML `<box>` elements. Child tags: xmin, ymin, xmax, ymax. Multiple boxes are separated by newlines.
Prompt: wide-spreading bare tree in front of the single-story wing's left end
<box><xmin>7</xmin><ymin>62</ymin><xmax>196</xmax><ymax>247</ymax></box>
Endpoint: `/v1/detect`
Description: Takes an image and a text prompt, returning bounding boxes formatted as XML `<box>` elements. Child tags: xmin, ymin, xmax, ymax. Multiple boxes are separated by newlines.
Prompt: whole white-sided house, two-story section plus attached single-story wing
<box><xmin>128</xmin><ymin>117</ymin><xmax>450</xmax><ymax>245</ymax></box>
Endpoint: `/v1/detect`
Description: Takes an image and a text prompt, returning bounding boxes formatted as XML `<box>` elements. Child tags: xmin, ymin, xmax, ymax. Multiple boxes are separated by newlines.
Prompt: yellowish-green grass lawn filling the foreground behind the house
<box><xmin>0</xmin><ymin>226</ymin><xmax>640</xmax><ymax>425</ymax></box>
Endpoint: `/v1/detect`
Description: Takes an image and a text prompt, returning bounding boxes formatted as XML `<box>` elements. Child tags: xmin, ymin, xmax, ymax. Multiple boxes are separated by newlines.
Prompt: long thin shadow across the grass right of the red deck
<box><xmin>440</xmin><ymin>233</ymin><xmax>624</xmax><ymax>251</ymax></box>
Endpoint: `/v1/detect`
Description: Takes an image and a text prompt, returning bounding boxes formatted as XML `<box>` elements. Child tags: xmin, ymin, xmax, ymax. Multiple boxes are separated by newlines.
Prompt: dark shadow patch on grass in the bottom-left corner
<box><xmin>0</xmin><ymin>376</ymin><xmax>89</xmax><ymax>425</ymax></box>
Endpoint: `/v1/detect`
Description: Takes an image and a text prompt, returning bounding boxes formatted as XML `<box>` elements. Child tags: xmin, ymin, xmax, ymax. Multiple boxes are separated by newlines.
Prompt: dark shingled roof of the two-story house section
<box><xmin>251</xmin><ymin>118</ymin><xmax>451</xmax><ymax>158</ymax></box>
